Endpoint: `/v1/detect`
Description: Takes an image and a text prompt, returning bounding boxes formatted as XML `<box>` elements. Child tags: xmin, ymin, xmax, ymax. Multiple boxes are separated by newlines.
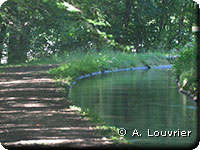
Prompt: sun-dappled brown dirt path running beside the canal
<box><xmin>0</xmin><ymin>66</ymin><xmax>116</xmax><ymax>148</ymax></box>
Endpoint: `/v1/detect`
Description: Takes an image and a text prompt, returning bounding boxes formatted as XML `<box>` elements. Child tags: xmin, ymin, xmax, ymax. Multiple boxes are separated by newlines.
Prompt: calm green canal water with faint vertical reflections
<box><xmin>70</xmin><ymin>69</ymin><xmax>198</xmax><ymax>147</ymax></box>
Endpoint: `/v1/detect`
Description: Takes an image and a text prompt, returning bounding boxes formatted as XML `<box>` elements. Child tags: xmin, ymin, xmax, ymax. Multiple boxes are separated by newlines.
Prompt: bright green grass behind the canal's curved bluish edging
<box><xmin>49</xmin><ymin>51</ymin><xmax>168</xmax><ymax>85</ymax></box>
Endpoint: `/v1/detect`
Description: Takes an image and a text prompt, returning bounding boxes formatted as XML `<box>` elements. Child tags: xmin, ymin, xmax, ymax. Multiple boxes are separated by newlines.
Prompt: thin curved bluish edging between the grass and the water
<box><xmin>69</xmin><ymin>64</ymin><xmax>173</xmax><ymax>89</ymax></box>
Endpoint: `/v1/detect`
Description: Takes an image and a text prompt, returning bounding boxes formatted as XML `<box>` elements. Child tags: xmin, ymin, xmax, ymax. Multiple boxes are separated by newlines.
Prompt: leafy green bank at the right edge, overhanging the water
<box><xmin>173</xmin><ymin>43</ymin><xmax>198</xmax><ymax>100</ymax></box>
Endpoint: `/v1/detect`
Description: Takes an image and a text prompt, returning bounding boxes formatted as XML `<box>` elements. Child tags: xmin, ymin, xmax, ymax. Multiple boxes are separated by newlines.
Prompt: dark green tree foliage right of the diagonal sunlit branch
<box><xmin>74</xmin><ymin>0</ymin><xmax>197</xmax><ymax>52</ymax></box>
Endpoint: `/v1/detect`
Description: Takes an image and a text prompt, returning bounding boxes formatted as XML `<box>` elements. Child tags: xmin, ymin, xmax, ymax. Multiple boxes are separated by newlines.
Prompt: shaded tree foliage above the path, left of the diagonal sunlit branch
<box><xmin>0</xmin><ymin>0</ymin><xmax>104</xmax><ymax>64</ymax></box>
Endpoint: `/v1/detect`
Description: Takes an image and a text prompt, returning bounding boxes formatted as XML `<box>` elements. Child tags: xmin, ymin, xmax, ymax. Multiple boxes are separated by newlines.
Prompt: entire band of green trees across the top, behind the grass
<box><xmin>0</xmin><ymin>0</ymin><xmax>198</xmax><ymax>64</ymax></box>
